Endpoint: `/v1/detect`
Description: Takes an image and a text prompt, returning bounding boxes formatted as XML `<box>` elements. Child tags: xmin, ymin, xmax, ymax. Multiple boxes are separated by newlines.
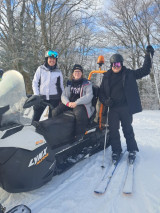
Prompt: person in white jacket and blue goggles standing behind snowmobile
<box><xmin>32</xmin><ymin>50</ymin><xmax>64</xmax><ymax>121</ymax></box>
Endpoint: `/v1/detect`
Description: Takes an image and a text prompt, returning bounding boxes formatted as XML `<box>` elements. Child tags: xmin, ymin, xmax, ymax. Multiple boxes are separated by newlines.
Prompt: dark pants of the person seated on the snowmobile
<box><xmin>52</xmin><ymin>103</ymin><xmax>88</xmax><ymax>136</ymax></box>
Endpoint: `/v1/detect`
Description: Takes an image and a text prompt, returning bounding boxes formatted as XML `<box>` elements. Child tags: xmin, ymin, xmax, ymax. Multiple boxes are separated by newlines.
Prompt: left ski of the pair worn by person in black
<box><xmin>94</xmin><ymin>150</ymin><xmax>126</xmax><ymax>194</ymax></box>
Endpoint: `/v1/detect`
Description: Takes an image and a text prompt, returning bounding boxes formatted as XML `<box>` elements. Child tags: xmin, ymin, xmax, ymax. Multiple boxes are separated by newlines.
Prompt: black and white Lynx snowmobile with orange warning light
<box><xmin>0</xmin><ymin>56</ymin><xmax>109</xmax><ymax>193</ymax></box>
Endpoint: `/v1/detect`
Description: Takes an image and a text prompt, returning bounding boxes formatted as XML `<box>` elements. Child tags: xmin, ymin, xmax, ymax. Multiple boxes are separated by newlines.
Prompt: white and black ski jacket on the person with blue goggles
<box><xmin>32</xmin><ymin>65</ymin><xmax>64</xmax><ymax>100</ymax></box>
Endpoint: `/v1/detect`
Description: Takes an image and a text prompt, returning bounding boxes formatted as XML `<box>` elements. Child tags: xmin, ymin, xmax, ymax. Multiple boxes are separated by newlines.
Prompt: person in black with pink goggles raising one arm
<box><xmin>99</xmin><ymin>45</ymin><xmax>154</xmax><ymax>161</ymax></box>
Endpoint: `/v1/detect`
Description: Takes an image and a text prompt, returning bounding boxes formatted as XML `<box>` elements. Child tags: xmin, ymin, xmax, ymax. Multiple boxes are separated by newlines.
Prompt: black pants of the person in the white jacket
<box><xmin>33</xmin><ymin>99</ymin><xmax>60</xmax><ymax>121</ymax></box>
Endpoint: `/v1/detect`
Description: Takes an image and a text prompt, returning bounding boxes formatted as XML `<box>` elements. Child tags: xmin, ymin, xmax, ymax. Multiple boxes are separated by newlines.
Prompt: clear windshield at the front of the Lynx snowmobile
<box><xmin>0</xmin><ymin>70</ymin><xmax>33</xmax><ymax>127</ymax></box>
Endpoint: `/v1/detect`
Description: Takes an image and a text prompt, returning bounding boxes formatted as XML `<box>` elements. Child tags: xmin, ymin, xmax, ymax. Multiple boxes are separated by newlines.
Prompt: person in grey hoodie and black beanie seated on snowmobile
<box><xmin>52</xmin><ymin>64</ymin><xmax>94</xmax><ymax>140</ymax></box>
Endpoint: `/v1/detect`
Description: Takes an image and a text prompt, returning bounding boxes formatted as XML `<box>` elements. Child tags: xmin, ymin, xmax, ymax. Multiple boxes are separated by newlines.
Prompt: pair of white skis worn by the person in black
<box><xmin>94</xmin><ymin>151</ymin><xmax>134</xmax><ymax>194</ymax></box>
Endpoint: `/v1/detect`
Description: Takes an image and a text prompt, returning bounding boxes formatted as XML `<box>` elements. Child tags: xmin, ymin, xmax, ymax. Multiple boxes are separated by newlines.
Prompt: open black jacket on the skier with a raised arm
<box><xmin>99</xmin><ymin>54</ymin><xmax>151</xmax><ymax>114</ymax></box>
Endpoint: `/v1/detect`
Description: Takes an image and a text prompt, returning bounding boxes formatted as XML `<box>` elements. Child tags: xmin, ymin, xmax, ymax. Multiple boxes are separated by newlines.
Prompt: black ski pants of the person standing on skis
<box><xmin>108</xmin><ymin>106</ymin><xmax>139</xmax><ymax>152</ymax></box>
